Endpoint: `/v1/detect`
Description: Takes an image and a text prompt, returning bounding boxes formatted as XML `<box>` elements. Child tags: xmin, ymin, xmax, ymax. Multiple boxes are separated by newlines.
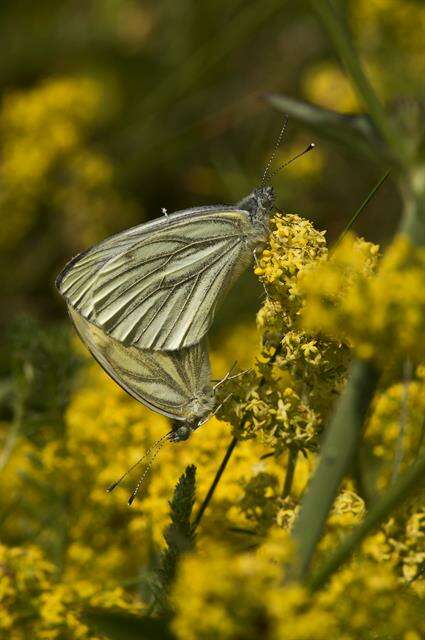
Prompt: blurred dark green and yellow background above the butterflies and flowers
<box><xmin>0</xmin><ymin>0</ymin><xmax>425</xmax><ymax>336</ymax></box>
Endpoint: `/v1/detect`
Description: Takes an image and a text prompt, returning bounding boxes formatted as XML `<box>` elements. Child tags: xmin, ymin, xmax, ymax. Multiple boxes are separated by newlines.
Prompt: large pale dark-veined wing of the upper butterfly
<box><xmin>58</xmin><ymin>206</ymin><xmax>255</xmax><ymax>350</ymax></box>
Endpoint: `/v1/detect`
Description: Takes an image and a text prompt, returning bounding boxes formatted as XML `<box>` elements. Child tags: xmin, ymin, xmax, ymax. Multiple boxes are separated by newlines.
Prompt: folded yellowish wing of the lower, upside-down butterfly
<box><xmin>68</xmin><ymin>306</ymin><xmax>211</xmax><ymax>420</ymax></box>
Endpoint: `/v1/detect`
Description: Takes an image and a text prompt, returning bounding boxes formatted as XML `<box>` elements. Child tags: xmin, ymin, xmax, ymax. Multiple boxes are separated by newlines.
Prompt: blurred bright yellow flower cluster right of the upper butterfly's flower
<box><xmin>300</xmin><ymin>236</ymin><xmax>425</xmax><ymax>364</ymax></box>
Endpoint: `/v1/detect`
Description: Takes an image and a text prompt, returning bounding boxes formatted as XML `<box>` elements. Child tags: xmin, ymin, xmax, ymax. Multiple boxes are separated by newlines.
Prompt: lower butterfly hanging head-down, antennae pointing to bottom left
<box><xmin>68</xmin><ymin>306</ymin><xmax>237</xmax><ymax>504</ymax></box>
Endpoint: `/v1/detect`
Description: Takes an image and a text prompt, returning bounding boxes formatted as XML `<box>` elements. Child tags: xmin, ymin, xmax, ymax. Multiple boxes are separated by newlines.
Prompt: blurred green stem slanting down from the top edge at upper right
<box><xmin>311</xmin><ymin>0</ymin><xmax>402</xmax><ymax>159</ymax></box>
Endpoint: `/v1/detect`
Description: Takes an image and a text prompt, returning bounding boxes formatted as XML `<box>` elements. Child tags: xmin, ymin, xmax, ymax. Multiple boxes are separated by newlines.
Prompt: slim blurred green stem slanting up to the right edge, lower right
<box><xmin>309</xmin><ymin>456</ymin><xmax>425</xmax><ymax>591</ymax></box>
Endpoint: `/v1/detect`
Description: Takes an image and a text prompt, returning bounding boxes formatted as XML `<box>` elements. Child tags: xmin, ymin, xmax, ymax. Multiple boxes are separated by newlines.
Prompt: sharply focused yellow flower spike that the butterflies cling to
<box><xmin>220</xmin><ymin>213</ymin><xmax>348</xmax><ymax>454</ymax></box>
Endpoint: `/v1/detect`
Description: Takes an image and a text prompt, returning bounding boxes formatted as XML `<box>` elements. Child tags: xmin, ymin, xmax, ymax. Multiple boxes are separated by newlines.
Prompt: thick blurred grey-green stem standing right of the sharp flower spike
<box><xmin>292</xmin><ymin>360</ymin><xmax>378</xmax><ymax>579</ymax></box>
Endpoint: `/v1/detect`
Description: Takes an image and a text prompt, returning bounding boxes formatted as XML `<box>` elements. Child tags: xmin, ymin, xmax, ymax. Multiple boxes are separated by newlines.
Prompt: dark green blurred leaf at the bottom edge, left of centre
<box><xmin>83</xmin><ymin>608</ymin><xmax>174</xmax><ymax>640</ymax></box>
